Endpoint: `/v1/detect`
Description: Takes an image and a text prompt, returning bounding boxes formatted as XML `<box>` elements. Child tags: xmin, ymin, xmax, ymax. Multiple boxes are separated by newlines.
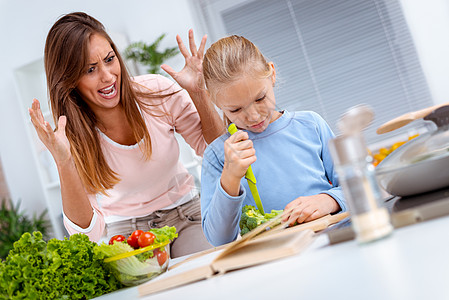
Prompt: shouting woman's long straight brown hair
<box><xmin>44</xmin><ymin>12</ymin><xmax>176</xmax><ymax>193</ymax></box>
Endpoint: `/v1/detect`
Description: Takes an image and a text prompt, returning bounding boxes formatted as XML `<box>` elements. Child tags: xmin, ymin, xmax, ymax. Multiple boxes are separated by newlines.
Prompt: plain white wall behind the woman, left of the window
<box><xmin>0</xmin><ymin>0</ymin><xmax>204</xmax><ymax>213</ymax></box>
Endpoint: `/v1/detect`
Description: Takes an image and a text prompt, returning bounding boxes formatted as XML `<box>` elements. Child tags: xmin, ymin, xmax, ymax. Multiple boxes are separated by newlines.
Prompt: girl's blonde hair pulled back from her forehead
<box><xmin>203</xmin><ymin>35</ymin><xmax>273</xmax><ymax>125</ymax></box>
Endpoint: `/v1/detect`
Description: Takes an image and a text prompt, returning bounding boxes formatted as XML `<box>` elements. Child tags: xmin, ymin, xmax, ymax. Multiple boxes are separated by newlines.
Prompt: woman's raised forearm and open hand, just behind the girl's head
<box><xmin>161</xmin><ymin>29</ymin><xmax>225</xmax><ymax>144</ymax></box>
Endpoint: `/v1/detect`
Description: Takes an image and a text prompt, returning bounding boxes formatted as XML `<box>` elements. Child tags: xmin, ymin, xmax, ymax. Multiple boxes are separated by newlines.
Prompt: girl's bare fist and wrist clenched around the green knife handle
<box><xmin>221</xmin><ymin>130</ymin><xmax>256</xmax><ymax>196</ymax></box>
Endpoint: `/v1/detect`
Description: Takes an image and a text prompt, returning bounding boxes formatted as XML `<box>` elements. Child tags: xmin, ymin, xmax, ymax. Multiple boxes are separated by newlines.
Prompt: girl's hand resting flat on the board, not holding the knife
<box><xmin>282</xmin><ymin>194</ymin><xmax>340</xmax><ymax>226</ymax></box>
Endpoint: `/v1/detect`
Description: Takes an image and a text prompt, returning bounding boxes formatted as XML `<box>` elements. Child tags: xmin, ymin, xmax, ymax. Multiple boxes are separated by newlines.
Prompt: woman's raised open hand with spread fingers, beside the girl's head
<box><xmin>161</xmin><ymin>29</ymin><xmax>207</xmax><ymax>93</ymax></box>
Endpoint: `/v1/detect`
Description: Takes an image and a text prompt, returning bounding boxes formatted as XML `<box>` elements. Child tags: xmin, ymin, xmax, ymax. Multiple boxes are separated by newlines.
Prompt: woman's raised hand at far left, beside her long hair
<box><xmin>28</xmin><ymin>99</ymin><xmax>72</xmax><ymax>164</ymax></box>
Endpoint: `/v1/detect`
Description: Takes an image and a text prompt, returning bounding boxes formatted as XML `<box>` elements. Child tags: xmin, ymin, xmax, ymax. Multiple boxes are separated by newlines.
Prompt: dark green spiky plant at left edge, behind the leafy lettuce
<box><xmin>0</xmin><ymin>200</ymin><xmax>48</xmax><ymax>259</ymax></box>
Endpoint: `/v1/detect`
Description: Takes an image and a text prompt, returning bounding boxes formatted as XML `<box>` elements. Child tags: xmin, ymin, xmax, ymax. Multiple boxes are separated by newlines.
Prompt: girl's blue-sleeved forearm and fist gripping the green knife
<box><xmin>201</xmin><ymin>130</ymin><xmax>256</xmax><ymax>246</ymax></box>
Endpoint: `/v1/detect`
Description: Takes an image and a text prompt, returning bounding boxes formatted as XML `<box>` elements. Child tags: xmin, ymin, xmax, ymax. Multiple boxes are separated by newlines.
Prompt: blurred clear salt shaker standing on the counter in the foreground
<box><xmin>329</xmin><ymin>105</ymin><xmax>393</xmax><ymax>243</ymax></box>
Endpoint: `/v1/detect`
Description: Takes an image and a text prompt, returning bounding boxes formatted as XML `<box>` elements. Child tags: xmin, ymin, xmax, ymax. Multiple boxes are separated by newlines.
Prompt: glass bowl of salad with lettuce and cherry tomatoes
<box><xmin>100</xmin><ymin>226</ymin><xmax>177</xmax><ymax>286</ymax></box>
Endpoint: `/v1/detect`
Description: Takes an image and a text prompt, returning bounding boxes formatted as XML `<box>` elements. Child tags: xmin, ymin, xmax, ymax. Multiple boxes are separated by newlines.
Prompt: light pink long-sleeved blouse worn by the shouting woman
<box><xmin>64</xmin><ymin>74</ymin><xmax>206</xmax><ymax>241</ymax></box>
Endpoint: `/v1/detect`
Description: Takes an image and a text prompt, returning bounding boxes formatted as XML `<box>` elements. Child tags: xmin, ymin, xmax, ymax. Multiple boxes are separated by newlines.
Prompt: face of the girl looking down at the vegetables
<box><xmin>215</xmin><ymin>63</ymin><xmax>280</xmax><ymax>132</ymax></box>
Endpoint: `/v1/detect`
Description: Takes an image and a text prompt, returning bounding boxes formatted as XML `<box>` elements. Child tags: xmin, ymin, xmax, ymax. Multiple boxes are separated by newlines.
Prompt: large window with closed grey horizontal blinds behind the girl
<box><xmin>197</xmin><ymin>0</ymin><xmax>433</xmax><ymax>144</ymax></box>
